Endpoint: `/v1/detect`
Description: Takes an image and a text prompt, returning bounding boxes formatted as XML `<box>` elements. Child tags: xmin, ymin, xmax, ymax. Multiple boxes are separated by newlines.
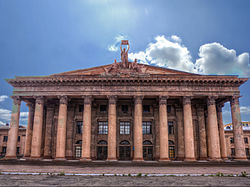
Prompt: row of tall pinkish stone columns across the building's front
<box><xmin>6</xmin><ymin>96</ymin><xmax>246</xmax><ymax>161</ymax></box>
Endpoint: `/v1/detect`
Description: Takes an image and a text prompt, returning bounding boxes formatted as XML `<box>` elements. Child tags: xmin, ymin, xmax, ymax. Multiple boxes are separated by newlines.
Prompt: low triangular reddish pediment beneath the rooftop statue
<box><xmin>53</xmin><ymin>62</ymin><xmax>197</xmax><ymax>75</ymax></box>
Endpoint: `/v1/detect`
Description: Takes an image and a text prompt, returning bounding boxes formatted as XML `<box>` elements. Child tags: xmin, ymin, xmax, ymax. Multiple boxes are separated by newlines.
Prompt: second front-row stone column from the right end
<box><xmin>207</xmin><ymin>97</ymin><xmax>221</xmax><ymax>160</ymax></box>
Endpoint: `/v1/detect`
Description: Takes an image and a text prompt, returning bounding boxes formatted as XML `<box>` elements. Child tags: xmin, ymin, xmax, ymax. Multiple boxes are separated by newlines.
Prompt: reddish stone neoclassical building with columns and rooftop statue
<box><xmin>3</xmin><ymin>41</ymin><xmax>247</xmax><ymax>161</ymax></box>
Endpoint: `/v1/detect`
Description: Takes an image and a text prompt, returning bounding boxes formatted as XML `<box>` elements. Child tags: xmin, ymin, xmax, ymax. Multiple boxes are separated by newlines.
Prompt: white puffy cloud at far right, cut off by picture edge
<box><xmin>196</xmin><ymin>42</ymin><xmax>250</xmax><ymax>77</ymax></box>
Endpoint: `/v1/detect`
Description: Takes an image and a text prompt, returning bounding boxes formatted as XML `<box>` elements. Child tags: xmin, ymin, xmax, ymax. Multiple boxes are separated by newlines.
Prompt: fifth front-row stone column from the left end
<box><xmin>108</xmin><ymin>96</ymin><xmax>117</xmax><ymax>161</ymax></box>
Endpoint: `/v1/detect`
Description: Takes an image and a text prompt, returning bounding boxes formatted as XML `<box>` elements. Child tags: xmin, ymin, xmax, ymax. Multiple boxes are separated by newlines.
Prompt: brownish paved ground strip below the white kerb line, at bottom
<box><xmin>0</xmin><ymin>175</ymin><xmax>250</xmax><ymax>186</ymax></box>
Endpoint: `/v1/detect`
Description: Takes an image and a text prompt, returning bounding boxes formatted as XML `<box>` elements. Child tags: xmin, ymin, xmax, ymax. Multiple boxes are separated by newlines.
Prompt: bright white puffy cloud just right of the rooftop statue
<box><xmin>129</xmin><ymin>35</ymin><xmax>196</xmax><ymax>72</ymax></box>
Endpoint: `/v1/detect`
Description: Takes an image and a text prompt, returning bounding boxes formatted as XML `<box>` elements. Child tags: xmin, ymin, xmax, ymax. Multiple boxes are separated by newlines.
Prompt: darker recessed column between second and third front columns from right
<box><xmin>197</xmin><ymin>106</ymin><xmax>207</xmax><ymax>160</ymax></box>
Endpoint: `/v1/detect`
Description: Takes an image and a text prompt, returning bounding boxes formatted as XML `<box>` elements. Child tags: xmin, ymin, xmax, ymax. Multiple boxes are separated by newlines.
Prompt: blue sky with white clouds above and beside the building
<box><xmin>0</xmin><ymin>0</ymin><xmax>250</xmax><ymax>125</ymax></box>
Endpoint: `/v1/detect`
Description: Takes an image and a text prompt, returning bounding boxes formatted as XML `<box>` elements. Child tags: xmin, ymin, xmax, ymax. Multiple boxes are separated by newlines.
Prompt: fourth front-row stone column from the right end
<box><xmin>159</xmin><ymin>96</ymin><xmax>169</xmax><ymax>161</ymax></box>
